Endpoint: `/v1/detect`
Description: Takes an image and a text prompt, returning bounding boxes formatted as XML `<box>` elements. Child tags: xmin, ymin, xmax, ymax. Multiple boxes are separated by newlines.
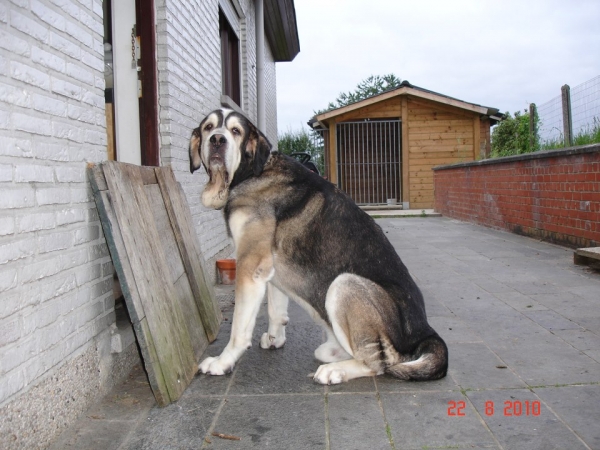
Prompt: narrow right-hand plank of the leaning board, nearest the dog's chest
<box><xmin>156</xmin><ymin>168</ymin><xmax>222</xmax><ymax>342</ymax></box>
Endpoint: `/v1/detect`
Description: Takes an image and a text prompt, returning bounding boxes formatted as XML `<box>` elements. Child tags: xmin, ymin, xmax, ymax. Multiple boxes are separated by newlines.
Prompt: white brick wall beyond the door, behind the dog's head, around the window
<box><xmin>157</xmin><ymin>0</ymin><xmax>277</xmax><ymax>263</ymax></box>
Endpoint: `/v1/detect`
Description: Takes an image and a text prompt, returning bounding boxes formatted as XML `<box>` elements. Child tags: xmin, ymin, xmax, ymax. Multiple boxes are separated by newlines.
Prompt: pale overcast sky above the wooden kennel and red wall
<box><xmin>277</xmin><ymin>0</ymin><xmax>600</xmax><ymax>133</ymax></box>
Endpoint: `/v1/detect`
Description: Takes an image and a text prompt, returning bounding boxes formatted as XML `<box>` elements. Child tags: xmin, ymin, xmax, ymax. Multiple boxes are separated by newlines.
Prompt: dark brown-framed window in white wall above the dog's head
<box><xmin>219</xmin><ymin>10</ymin><xmax>241</xmax><ymax>106</ymax></box>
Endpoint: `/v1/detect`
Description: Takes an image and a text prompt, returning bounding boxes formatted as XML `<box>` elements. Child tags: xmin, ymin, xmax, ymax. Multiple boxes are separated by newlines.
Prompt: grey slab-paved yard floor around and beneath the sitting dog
<box><xmin>51</xmin><ymin>217</ymin><xmax>600</xmax><ymax>450</ymax></box>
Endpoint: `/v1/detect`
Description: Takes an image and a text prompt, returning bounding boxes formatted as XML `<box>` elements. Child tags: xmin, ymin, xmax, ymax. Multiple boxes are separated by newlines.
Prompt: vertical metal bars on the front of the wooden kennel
<box><xmin>336</xmin><ymin>120</ymin><xmax>402</xmax><ymax>205</ymax></box>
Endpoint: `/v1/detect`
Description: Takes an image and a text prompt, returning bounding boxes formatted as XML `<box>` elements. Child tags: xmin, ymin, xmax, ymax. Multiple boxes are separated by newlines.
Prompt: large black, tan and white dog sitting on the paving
<box><xmin>189</xmin><ymin>109</ymin><xmax>448</xmax><ymax>384</ymax></box>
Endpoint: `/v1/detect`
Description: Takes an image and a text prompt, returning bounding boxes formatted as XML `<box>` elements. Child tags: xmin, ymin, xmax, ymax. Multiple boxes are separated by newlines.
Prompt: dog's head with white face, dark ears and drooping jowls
<box><xmin>190</xmin><ymin>109</ymin><xmax>271</xmax><ymax>209</ymax></box>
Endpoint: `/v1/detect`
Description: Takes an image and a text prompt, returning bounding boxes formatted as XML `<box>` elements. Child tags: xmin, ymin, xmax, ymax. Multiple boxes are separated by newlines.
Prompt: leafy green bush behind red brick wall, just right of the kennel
<box><xmin>491</xmin><ymin>111</ymin><xmax>540</xmax><ymax>158</ymax></box>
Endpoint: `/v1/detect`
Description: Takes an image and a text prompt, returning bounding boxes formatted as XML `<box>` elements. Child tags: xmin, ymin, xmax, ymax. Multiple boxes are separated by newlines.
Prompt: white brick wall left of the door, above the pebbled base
<box><xmin>0</xmin><ymin>0</ymin><xmax>114</xmax><ymax>406</ymax></box>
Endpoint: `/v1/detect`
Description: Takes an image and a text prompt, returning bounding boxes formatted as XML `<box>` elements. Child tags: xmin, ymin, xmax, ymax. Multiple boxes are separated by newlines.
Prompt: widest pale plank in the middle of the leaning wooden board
<box><xmin>103</xmin><ymin>161</ymin><xmax>196</xmax><ymax>401</ymax></box>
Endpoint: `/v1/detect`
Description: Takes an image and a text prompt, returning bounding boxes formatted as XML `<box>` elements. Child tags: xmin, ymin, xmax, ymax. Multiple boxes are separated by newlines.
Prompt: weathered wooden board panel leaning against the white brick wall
<box><xmin>89</xmin><ymin>161</ymin><xmax>222</xmax><ymax>406</ymax></box>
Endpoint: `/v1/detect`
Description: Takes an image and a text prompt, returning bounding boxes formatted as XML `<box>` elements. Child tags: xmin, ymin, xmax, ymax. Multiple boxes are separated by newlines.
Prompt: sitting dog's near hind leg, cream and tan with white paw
<box><xmin>314</xmin><ymin>274</ymin><xmax>387</xmax><ymax>384</ymax></box>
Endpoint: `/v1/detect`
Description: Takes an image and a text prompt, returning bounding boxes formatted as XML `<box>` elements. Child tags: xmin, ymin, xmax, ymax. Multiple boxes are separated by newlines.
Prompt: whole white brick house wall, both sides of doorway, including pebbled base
<box><xmin>0</xmin><ymin>0</ymin><xmax>276</xmax><ymax>449</ymax></box>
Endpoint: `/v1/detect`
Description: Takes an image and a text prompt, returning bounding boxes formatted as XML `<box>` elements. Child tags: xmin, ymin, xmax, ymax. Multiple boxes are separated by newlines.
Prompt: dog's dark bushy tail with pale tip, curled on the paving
<box><xmin>385</xmin><ymin>334</ymin><xmax>448</xmax><ymax>381</ymax></box>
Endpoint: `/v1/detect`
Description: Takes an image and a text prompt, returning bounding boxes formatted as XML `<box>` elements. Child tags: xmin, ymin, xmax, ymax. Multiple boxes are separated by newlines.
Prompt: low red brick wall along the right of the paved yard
<box><xmin>434</xmin><ymin>145</ymin><xmax>600</xmax><ymax>247</ymax></box>
